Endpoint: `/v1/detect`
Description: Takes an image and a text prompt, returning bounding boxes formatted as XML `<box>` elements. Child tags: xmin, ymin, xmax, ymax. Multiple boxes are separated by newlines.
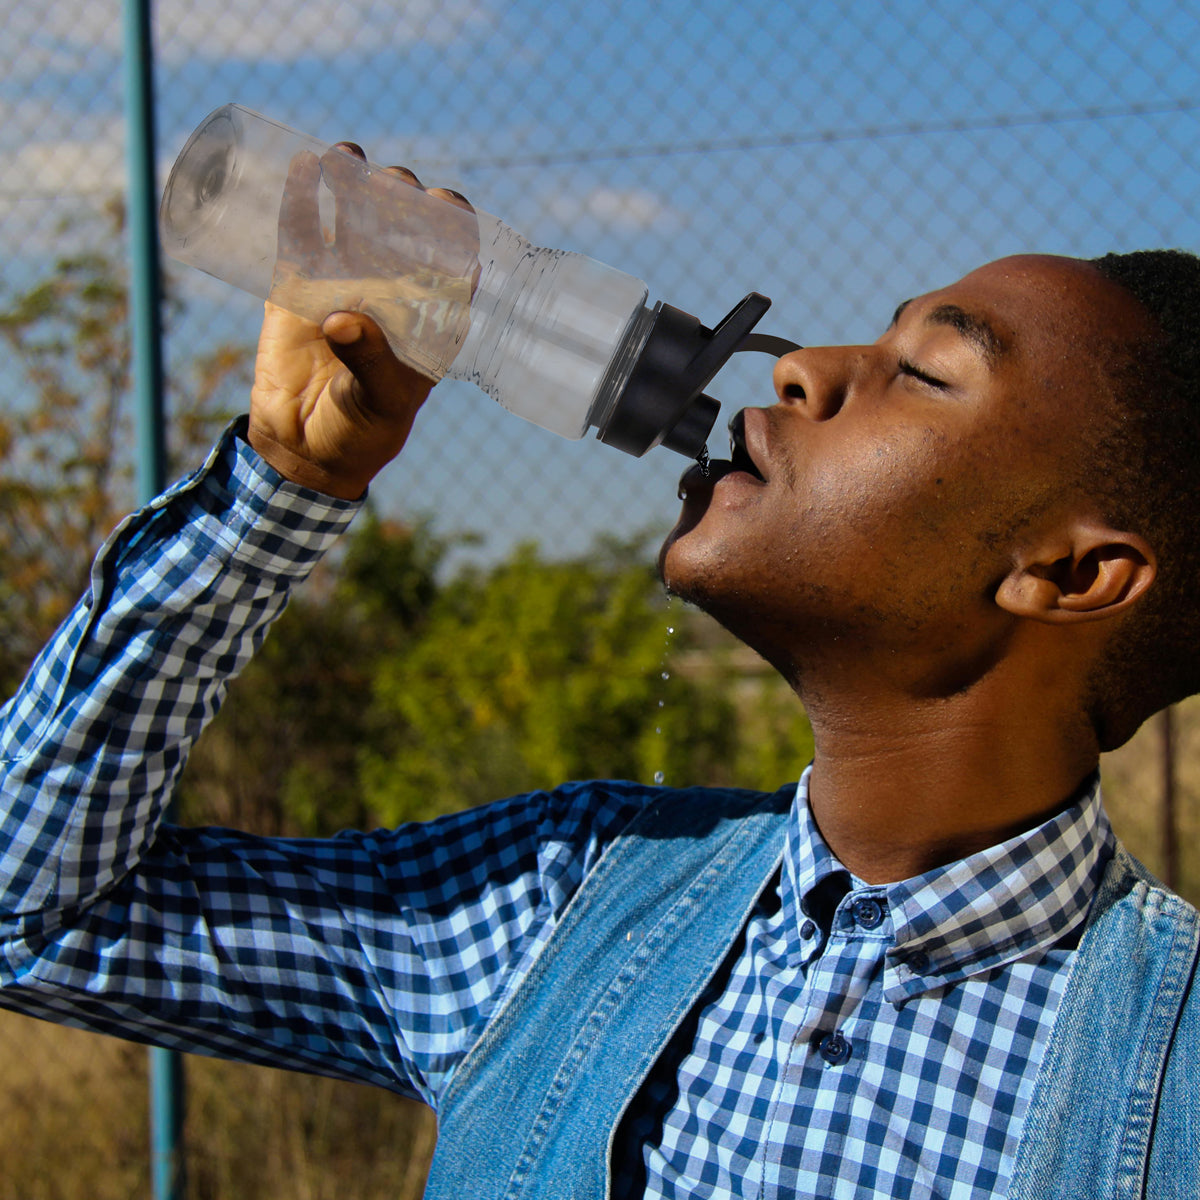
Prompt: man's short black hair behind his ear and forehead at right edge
<box><xmin>1088</xmin><ymin>250</ymin><xmax>1200</xmax><ymax>750</ymax></box>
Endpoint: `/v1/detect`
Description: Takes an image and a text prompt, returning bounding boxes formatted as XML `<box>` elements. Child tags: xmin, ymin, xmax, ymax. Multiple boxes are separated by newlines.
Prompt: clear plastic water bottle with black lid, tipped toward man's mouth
<box><xmin>160</xmin><ymin>104</ymin><xmax>793</xmax><ymax>456</ymax></box>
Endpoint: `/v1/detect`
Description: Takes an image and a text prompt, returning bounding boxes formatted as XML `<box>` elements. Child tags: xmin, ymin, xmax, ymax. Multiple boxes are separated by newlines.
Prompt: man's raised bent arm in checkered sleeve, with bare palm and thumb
<box><xmin>0</xmin><ymin>288</ymin><xmax>644</xmax><ymax>1100</ymax></box>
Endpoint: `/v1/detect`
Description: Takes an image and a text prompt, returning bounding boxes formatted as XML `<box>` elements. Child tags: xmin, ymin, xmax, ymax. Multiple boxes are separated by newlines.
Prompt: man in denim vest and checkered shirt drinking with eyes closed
<box><xmin>0</xmin><ymin>164</ymin><xmax>1200</xmax><ymax>1198</ymax></box>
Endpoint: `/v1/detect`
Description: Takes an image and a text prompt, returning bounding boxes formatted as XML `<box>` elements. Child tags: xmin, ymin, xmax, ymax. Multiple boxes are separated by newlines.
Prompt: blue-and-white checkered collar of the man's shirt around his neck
<box><xmin>781</xmin><ymin>768</ymin><xmax>1116</xmax><ymax>1004</ymax></box>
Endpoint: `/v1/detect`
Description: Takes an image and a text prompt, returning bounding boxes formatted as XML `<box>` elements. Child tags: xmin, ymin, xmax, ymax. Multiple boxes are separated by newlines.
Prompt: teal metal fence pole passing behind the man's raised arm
<box><xmin>125</xmin><ymin>0</ymin><xmax>184</xmax><ymax>1200</ymax></box>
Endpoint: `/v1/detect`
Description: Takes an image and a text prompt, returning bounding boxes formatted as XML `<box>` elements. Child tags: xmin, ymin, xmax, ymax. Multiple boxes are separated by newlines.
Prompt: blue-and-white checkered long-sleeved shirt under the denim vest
<box><xmin>0</xmin><ymin>427</ymin><xmax>1112</xmax><ymax>1200</ymax></box>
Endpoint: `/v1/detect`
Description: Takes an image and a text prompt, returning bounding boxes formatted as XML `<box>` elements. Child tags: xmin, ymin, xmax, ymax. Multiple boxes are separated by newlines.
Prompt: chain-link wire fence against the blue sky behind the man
<box><xmin>0</xmin><ymin>0</ymin><xmax>1200</xmax><ymax>1200</ymax></box>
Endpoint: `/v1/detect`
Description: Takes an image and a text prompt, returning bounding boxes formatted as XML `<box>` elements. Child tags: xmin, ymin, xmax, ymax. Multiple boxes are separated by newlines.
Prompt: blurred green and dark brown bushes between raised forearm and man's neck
<box><xmin>179</xmin><ymin>512</ymin><xmax>811</xmax><ymax>835</ymax></box>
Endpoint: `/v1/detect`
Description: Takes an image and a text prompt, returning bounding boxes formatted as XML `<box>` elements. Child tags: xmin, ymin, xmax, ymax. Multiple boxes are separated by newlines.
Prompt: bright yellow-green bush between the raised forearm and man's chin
<box><xmin>360</xmin><ymin>544</ymin><xmax>801</xmax><ymax>823</ymax></box>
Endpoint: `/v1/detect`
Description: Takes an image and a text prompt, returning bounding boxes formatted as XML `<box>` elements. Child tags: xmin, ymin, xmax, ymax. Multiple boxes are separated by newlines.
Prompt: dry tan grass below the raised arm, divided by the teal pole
<box><xmin>0</xmin><ymin>1013</ymin><xmax>434</xmax><ymax>1200</ymax></box>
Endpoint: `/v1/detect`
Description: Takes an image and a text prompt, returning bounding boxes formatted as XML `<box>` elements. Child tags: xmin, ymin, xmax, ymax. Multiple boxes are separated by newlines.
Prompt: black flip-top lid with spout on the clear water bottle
<box><xmin>596</xmin><ymin>292</ymin><xmax>797</xmax><ymax>458</ymax></box>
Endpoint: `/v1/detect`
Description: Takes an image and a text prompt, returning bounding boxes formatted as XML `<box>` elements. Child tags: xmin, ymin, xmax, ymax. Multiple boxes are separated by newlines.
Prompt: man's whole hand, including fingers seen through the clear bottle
<box><xmin>248</xmin><ymin>143</ymin><xmax>479</xmax><ymax>499</ymax></box>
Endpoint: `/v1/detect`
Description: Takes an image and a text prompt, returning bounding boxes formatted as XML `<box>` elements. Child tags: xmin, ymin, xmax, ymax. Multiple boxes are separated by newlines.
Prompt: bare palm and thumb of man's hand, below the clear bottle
<box><xmin>247</xmin><ymin>302</ymin><xmax>433</xmax><ymax>500</ymax></box>
